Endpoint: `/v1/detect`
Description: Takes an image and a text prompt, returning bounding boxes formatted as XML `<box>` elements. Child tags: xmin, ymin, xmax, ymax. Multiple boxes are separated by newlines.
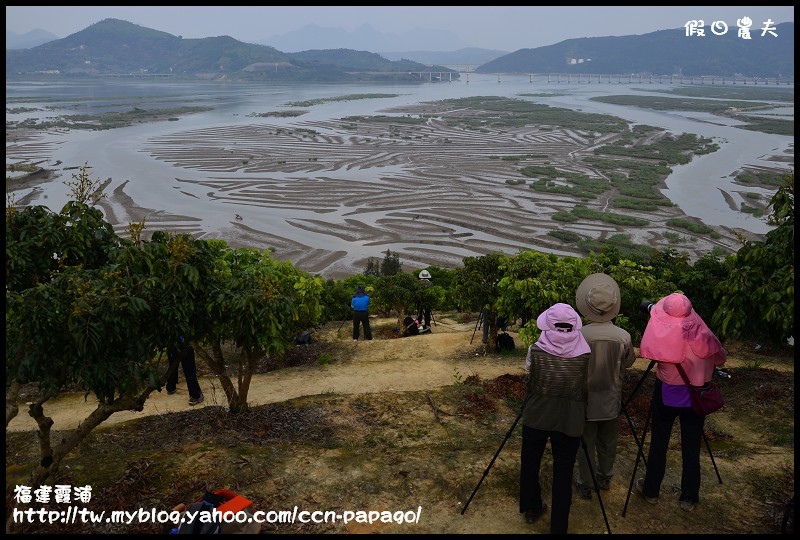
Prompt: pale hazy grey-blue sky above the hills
<box><xmin>6</xmin><ymin>6</ymin><xmax>794</xmax><ymax>52</ymax></box>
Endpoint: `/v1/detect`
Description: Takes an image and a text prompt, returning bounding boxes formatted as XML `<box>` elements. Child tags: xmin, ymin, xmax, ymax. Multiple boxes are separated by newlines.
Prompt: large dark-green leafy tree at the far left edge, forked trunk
<box><xmin>6</xmin><ymin>166</ymin><xmax>227</xmax><ymax>485</ymax></box>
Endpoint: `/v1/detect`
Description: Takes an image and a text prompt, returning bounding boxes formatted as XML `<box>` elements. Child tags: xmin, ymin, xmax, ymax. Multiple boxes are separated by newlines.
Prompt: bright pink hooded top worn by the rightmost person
<box><xmin>639</xmin><ymin>293</ymin><xmax>727</xmax><ymax>386</ymax></box>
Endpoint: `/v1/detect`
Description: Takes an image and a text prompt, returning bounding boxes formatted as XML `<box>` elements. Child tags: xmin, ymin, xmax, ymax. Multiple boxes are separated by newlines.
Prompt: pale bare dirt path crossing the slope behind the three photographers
<box><xmin>8</xmin><ymin>319</ymin><xmax>522</xmax><ymax>431</ymax></box>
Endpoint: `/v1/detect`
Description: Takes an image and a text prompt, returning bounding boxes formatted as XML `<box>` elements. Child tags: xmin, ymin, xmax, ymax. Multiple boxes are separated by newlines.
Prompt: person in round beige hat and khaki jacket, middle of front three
<box><xmin>575</xmin><ymin>273</ymin><xmax>636</xmax><ymax>500</ymax></box>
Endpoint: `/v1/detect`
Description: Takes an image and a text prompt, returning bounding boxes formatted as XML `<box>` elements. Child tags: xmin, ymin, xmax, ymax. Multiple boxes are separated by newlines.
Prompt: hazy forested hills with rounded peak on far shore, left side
<box><xmin>6</xmin><ymin>19</ymin><xmax>458</xmax><ymax>82</ymax></box>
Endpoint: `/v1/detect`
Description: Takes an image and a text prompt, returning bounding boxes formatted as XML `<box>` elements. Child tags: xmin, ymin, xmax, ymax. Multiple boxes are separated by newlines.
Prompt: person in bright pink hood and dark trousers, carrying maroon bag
<box><xmin>636</xmin><ymin>293</ymin><xmax>727</xmax><ymax>511</ymax></box>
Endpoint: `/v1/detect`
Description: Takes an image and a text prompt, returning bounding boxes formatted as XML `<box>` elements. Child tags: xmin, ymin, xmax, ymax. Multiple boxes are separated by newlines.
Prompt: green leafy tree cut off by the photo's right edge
<box><xmin>713</xmin><ymin>172</ymin><xmax>794</xmax><ymax>343</ymax></box>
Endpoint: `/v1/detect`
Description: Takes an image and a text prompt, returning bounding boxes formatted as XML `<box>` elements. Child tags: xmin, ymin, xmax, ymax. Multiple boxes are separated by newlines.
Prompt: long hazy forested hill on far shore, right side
<box><xmin>476</xmin><ymin>22</ymin><xmax>794</xmax><ymax>78</ymax></box>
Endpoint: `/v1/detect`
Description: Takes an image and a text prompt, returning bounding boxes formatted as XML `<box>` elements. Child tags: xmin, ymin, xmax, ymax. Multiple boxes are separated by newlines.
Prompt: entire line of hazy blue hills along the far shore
<box><xmin>6</xmin><ymin>19</ymin><xmax>794</xmax><ymax>82</ymax></box>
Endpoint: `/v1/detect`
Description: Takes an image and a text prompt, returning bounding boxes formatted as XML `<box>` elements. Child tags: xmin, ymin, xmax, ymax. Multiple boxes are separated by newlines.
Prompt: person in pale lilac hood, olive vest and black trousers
<box><xmin>519</xmin><ymin>304</ymin><xmax>589</xmax><ymax>534</ymax></box>
